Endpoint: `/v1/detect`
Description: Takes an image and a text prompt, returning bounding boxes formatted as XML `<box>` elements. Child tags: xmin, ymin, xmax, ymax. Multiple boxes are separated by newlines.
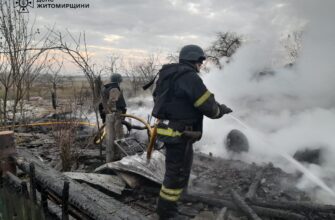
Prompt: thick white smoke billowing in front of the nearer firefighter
<box><xmin>197</xmin><ymin>0</ymin><xmax>335</xmax><ymax>203</ymax></box>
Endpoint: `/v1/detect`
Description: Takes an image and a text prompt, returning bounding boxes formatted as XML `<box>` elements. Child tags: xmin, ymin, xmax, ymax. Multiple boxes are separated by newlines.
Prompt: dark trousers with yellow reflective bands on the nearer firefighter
<box><xmin>157</xmin><ymin>142</ymin><xmax>193</xmax><ymax>219</ymax></box>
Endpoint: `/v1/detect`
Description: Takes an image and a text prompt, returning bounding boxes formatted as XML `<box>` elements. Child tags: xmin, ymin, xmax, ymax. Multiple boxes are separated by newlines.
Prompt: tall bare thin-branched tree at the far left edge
<box><xmin>0</xmin><ymin>0</ymin><xmax>54</xmax><ymax>124</ymax></box>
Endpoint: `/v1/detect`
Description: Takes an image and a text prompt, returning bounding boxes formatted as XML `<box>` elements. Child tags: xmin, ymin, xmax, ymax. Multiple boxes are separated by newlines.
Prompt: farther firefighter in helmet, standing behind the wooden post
<box><xmin>99</xmin><ymin>73</ymin><xmax>127</xmax><ymax>123</ymax></box>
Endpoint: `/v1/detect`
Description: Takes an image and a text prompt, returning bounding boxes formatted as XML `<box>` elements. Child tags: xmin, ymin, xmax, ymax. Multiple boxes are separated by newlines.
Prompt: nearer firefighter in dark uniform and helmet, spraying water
<box><xmin>152</xmin><ymin>45</ymin><xmax>232</xmax><ymax>219</ymax></box>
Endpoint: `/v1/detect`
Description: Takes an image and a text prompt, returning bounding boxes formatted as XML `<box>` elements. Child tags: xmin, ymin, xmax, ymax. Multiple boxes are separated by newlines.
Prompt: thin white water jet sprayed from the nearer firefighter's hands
<box><xmin>229</xmin><ymin>115</ymin><xmax>335</xmax><ymax>198</ymax></box>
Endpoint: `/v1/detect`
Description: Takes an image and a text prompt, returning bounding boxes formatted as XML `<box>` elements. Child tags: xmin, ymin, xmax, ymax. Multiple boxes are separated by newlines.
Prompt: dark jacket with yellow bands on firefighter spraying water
<box><xmin>152</xmin><ymin>63</ymin><xmax>220</xmax><ymax>143</ymax></box>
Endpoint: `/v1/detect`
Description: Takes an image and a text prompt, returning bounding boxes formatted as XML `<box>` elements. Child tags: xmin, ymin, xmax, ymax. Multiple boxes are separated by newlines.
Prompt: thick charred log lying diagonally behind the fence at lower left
<box><xmin>17</xmin><ymin>148</ymin><xmax>146</xmax><ymax>220</ymax></box>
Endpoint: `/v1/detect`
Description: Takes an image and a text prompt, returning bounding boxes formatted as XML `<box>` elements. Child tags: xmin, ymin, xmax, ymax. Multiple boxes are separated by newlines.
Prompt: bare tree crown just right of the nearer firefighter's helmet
<box><xmin>206</xmin><ymin>32</ymin><xmax>242</xmax><ymax>69</ymax></box>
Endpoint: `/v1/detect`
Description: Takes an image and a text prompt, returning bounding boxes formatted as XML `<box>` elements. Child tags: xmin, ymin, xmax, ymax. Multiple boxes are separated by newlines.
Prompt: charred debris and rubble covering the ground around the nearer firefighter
<box><xmin>2</xmin><ymin>127</ymin><xmax>335</xmax><ymax>220</ymax></box>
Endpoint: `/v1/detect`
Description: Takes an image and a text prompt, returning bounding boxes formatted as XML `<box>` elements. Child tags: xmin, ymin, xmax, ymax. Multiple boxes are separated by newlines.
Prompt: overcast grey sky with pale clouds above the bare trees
<box><xmin>29</xmin><ymin>0</ymin><xmax>310</xmax><ymax>67</ymax></box>
